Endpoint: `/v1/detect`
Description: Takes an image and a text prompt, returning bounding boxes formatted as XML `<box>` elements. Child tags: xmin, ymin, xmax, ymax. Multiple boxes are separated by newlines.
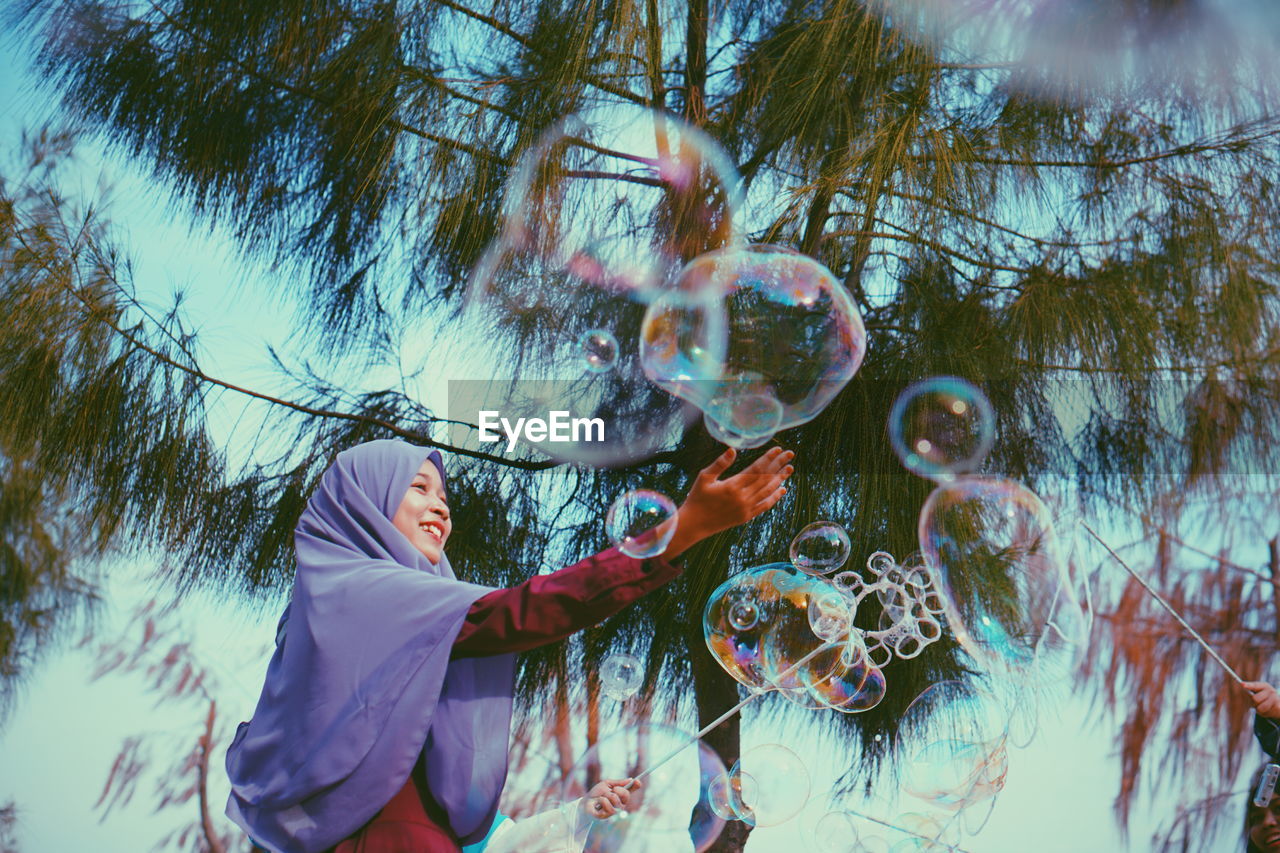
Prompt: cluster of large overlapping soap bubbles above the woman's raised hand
<box><xmin>467</xmin><ymin>108</ymin><xmax>867</xmax><ymax>465</ymax></box>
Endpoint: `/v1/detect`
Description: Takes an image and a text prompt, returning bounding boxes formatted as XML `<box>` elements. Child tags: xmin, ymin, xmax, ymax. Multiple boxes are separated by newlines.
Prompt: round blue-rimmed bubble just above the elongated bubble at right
<box><xmin>888</xmin><ymin>377</ymin><xmax>996</xmax><ymax>482</ymax></box>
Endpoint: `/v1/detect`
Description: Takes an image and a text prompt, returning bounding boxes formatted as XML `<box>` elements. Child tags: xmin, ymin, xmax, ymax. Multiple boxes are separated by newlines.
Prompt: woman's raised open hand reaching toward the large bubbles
<box><xmin>663</xmin><ymin>447</ymin><xmax>795</xmax><ymax>560</ymax></box>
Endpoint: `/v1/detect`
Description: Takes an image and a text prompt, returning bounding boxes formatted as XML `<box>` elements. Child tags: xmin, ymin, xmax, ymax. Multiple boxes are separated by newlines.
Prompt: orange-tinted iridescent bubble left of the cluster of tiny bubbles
<box><xmin>703</xmin><ymin>562</ymin><xmax>841</xmax><ymax>686</ymax></box>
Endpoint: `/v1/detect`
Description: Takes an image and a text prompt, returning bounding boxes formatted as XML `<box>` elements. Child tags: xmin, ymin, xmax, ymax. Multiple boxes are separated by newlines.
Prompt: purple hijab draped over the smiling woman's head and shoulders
<box><xmin>227</xmin><ymin>441</ymin><xmax>516</xmax><ymax>853</ymax></box>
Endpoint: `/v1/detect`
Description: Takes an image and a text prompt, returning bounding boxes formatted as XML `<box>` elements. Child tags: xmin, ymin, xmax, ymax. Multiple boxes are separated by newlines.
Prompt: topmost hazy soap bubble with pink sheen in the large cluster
<box><xmin>468</xmin><ymin>106</ymin><xmax>741</xmax><ymax>309</ymax></box>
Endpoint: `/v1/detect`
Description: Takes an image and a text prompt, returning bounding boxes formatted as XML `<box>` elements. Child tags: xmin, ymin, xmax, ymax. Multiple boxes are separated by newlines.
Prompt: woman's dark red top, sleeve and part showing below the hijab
<box><xmin>334</xmin><ymin>548</ymin><xmax>681</xmax><ymax>853</ymax></box>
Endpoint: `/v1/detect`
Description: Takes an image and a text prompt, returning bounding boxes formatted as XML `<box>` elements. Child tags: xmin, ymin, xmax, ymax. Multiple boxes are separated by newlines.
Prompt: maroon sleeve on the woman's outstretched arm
<box><xmin>452</xmin><ymin>548</ymin><xmax>681</xmax><ymax>657</ymax></box>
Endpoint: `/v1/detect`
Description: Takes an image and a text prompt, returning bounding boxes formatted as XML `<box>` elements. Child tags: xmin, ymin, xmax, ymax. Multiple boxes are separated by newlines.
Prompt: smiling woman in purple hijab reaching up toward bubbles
<box><xmin>227</xmin><ymin>441</ymin><xmax>794</xmax><ymax>853</ymax></box>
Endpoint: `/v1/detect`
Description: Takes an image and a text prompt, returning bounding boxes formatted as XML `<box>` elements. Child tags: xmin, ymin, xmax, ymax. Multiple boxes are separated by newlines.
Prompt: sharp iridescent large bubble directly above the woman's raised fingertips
<box><xmin>640</xmin><ymin>245</ymin><xmax>867</xmax><ymax>429</ymax></box>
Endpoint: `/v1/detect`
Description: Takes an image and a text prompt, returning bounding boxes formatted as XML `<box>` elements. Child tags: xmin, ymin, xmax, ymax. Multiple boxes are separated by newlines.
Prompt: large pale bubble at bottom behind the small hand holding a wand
<box><xmin>561</xmin><ymin>725</ymin><xmax>724</xmax><ymax>853</ymax></box>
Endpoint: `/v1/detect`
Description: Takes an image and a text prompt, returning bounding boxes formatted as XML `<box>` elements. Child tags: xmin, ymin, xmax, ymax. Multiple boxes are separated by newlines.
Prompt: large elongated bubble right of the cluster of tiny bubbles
<box><xmin>919</xmin><ymin>476</ymin><xmax>1087</xmax><ymax>684</ymax></box>
